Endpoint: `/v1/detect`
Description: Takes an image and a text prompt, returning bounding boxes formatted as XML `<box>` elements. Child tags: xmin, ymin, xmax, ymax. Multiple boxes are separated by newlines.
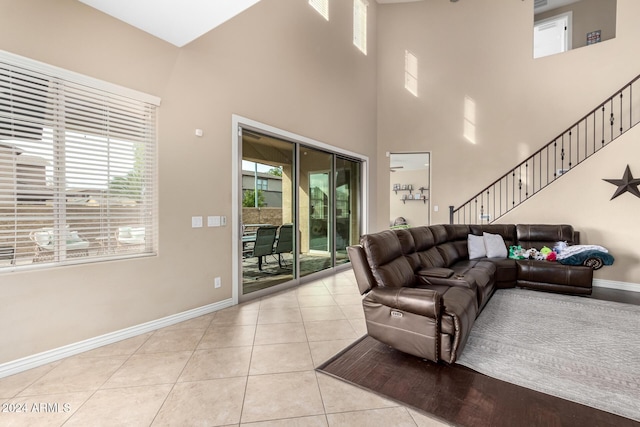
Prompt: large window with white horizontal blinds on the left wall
<box><xmin>0</xmin><ymin>51</ymin><xmax>159</xmax><ymax>271</ymax></box>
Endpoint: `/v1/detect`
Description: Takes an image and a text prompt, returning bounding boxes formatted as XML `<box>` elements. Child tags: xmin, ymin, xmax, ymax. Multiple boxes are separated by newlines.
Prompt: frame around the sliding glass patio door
<box><xmin>229</xmin><ymin>114</ymin><xmax>369</xmax><ymax>304</ymax></box>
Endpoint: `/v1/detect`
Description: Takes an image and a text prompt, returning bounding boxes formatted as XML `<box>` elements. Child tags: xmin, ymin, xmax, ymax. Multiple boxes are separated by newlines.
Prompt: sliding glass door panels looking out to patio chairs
<box><xmin>239</xmin><ymin>124</ymin><xmax>362</xmax><ymax>295</ymax></box>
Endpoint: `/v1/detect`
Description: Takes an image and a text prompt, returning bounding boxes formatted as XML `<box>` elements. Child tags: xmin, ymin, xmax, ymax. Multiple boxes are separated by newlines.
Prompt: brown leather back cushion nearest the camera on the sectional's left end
<box><xmin>360</xmin><ymin>230</ymin><xmax>415</xmax><ymax>288</ymax></box>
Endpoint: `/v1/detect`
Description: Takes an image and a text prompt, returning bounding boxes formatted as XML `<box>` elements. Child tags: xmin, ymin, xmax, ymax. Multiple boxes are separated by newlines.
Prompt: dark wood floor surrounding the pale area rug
<box><xmin>320</xmin><ymin>288</ymin><xmax>640</xmax><ymax>427</ymax></box>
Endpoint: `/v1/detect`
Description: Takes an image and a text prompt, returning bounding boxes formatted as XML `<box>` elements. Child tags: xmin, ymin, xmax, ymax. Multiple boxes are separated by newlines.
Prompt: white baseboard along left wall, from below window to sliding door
<box><xmin>0</xmin><ymin>298</ymin><xmax>233</xmax><ymax>378</ymax></box>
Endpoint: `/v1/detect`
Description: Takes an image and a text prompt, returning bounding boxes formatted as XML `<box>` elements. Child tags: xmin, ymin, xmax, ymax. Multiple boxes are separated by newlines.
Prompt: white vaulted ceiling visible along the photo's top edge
<box><xmin>78</xmin><ymin>0</ymin><xmax>422</xmax><ymax>47</ymax></box>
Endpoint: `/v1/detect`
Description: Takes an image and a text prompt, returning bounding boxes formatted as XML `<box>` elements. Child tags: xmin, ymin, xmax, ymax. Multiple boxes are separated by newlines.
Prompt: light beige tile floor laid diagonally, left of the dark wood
<box><xmin>0</xmin><ymin>270</ymin><xmax>445</xmax><ymax>427</ymax></box>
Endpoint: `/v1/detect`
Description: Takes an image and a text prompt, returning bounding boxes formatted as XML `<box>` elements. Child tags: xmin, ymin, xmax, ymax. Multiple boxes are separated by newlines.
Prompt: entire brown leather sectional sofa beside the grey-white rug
<box><xmin>348</xmin><ymin>224</ymin><xmax>593</xmax><ymax>363</ymax></box>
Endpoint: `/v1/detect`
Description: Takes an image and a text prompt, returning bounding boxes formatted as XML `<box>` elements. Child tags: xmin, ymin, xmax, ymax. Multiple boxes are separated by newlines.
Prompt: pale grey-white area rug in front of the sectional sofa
<box><xmin>457</xmin><ymin>289</ymin><xmax>640</xmax><ymax>421</ymax></box>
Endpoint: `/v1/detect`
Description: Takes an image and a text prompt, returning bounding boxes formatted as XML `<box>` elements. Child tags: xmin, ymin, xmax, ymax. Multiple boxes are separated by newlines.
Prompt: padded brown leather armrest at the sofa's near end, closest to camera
<box><xmin>366</xmin><ymin>287</ymin><xmax>442</xmax><ymax>319</ymax></box>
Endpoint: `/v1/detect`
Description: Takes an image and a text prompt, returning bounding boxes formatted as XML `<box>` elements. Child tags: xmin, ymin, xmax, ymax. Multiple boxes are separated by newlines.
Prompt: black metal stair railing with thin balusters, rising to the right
<box><xmin>449</xmin><ymin>75</ymin><xmax>640</xmax><ymax>224</ymax></box>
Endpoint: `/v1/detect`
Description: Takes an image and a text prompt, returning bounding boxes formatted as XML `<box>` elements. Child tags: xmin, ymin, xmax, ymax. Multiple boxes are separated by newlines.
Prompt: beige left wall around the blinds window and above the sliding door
<box><xmin>0</xmin><ymin>0</ymin><xmax>376</xmax><ymax>363</ymax></box>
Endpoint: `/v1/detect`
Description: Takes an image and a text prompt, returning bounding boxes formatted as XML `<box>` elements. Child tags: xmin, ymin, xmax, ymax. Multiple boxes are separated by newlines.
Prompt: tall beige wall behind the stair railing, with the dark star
<box><xmin>375</xmin><ymin>0</ymin><xmax>640</xmax><ymax>283</ymax></box>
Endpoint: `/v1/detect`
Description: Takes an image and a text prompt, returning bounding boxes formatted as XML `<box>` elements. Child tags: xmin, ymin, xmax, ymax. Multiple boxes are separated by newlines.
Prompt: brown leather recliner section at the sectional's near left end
<box><xmin>347</xmin><ymin>231</ymin><xmax>478</xmax><ymax>363</ymax></box>
